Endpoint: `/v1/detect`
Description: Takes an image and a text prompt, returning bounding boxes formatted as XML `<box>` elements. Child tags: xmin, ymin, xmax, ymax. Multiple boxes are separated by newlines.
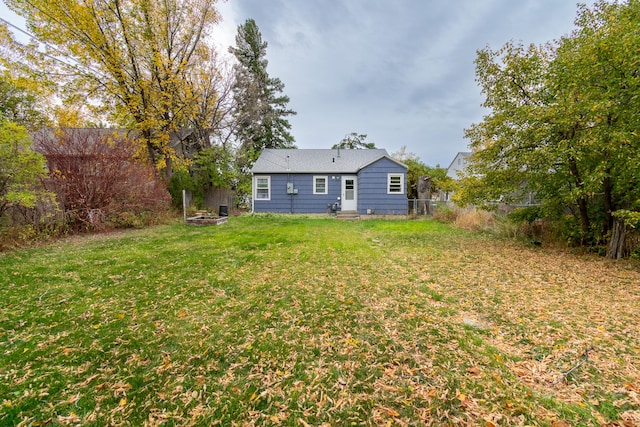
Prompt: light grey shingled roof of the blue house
<box><xmin>252</xmin><ymin>148</ymin><xmax>406</xmax><ymax>173</ymax></box>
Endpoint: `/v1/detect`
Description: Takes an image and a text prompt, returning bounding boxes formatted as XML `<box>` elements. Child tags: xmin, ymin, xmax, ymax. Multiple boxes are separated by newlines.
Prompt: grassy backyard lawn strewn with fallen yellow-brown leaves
<box><xmin>0</xmin><ymin>216</ymin><xmax>640</xmax><ymax>426</ymax></box>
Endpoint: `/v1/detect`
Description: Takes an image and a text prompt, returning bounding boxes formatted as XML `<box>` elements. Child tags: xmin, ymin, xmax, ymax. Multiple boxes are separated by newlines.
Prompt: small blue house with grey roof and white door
<box><xmin>252</xmin><ymin>149</ymin><xmax>408</xmax><ymax>215</ymax></box>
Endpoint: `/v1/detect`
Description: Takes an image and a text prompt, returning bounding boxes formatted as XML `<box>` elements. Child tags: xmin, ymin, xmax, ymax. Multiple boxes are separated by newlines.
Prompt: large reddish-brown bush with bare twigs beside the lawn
<box><xmin>33</xmin><ymin>129</ymin><xmax>169</xmax><ymax>231</ymax></box>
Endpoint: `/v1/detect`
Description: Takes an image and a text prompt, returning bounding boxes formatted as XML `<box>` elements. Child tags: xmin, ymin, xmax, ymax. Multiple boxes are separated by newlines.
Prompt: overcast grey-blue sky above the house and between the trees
<box><xmin>216</xmin><ymin>0</ymin><xmax>590</xmax><ymax>167</ymax></box>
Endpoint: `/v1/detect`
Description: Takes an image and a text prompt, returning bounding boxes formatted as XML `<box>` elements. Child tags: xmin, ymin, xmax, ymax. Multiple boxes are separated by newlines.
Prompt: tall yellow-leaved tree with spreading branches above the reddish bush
<box><xmin>5</xmin><ymin>0</ymin><xmax>219</xmax><ymax>178</ymax></box>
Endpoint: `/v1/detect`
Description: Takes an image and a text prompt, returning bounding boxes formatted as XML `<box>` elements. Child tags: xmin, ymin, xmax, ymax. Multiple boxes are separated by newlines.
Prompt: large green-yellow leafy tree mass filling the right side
<box><xmin>459</xmin><ymin>1</ymin><xmax>640</xmax><ymax>254</ymax></box>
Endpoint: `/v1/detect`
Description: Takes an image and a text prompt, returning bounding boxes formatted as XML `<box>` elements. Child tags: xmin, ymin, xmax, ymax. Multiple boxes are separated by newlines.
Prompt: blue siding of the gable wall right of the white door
<box><xmin>358</xmin><ymin>158</ymin><xmax>408</xmax><ymax>215</ymax></box>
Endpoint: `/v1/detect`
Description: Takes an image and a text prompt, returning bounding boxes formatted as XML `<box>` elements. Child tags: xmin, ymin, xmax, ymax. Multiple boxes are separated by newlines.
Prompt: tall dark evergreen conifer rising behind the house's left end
<box><xmin>229</xmin><ymin>19</ymin><xmax>296</xmax><ymax>168</ymax></box>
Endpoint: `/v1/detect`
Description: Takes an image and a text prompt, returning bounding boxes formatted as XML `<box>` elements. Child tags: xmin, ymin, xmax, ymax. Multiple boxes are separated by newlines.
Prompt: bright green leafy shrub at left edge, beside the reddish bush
<box><xmin>0</xmin><ymin>118</ymin><xmax>47</xmax><ymax>221</ymax></box>
